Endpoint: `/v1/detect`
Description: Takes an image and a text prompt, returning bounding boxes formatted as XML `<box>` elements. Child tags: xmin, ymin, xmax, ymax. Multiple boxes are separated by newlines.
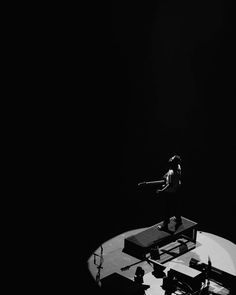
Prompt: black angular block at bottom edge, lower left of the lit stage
<box><xmin>101</xmin><ymin>272</ymin><xmax>150</xmax><ymax>295</ymax></box>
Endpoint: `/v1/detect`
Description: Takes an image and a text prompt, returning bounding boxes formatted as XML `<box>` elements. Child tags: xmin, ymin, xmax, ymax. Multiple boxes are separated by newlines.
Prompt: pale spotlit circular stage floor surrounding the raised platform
<box><xmin>88</xmin><ymin>228</ymin><xmax>236</xmax><ymax>295</ymax></box>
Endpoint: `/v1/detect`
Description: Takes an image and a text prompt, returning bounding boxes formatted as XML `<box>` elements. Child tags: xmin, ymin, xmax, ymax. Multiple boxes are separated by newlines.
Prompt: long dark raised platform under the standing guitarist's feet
<box><xmin>123</xmin><ymin>217</ymin><xmax>197</xmax><ymax>263</ymax></box>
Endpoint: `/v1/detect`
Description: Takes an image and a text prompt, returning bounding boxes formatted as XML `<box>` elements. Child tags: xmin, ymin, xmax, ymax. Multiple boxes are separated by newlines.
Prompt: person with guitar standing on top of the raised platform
<box><xmin>156</xmin><ymin>155</ymin><xmax>182</xmax><ymax>230</ymax></box>
